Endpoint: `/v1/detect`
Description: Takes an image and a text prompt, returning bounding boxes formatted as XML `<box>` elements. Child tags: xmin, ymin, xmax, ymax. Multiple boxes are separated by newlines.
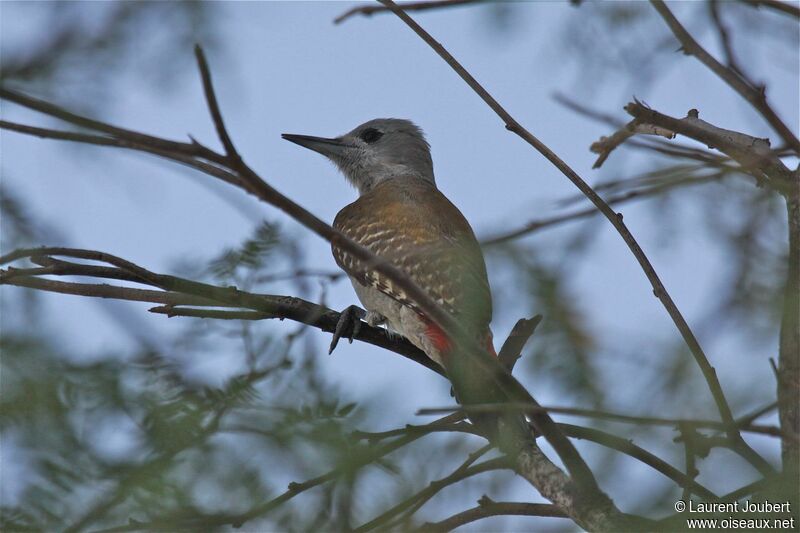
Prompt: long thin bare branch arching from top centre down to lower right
<box><xmin>379</xmin><ymin>0</ymin><xmax>773</xmax><ymax>475</ymax></box>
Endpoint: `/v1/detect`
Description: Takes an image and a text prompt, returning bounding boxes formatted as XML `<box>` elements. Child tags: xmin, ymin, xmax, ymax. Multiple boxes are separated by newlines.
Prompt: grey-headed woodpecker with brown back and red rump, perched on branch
<box><xmin>283</xmin><ymin>118</ymin><xmax>494</xmax><ymax>369</ymax></box>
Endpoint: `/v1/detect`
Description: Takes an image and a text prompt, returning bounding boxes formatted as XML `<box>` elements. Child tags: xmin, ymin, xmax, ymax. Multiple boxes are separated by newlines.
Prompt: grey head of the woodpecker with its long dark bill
<box><xmin>282</xmin><ymin>118</ymin><xmax>436</xmax><ymax>194</ymax></box>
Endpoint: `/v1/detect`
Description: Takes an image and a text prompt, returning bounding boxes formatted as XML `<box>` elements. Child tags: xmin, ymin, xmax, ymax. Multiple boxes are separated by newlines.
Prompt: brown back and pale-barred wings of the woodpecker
<box><xmin>333</xmin><ymin>178</ymin><xmax>492</xmax><ymax>331</ymax></box>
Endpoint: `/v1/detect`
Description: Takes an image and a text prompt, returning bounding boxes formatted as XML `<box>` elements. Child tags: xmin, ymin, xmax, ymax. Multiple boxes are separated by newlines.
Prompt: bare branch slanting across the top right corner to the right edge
<box><xmin>650</xmin><ymin>0</ymin><xmax>800</xmax><ymax>154</ymax></box>
